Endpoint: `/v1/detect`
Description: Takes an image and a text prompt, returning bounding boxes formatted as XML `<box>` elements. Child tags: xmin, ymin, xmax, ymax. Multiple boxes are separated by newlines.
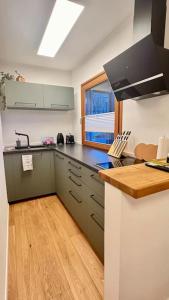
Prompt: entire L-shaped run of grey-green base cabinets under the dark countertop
<box><xmin>4</xmin><ymin>151</ymin><xmax>104</xmax><ymax>261</ymax></box>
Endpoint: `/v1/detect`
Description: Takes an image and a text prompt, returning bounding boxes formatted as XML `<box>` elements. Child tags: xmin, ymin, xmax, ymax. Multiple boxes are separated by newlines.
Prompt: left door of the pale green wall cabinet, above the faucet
<box><xmin>5</xmin><ymin>81</ymin><xmax>44</xmax><ymax>109</ymax></box>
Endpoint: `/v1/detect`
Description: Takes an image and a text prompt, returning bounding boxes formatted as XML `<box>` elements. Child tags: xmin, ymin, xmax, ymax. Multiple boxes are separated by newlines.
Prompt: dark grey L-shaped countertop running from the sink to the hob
<box><xmin>4</xmin><ymin>144</ymin><xmax>139</xmax><ymax>172</ymax></box>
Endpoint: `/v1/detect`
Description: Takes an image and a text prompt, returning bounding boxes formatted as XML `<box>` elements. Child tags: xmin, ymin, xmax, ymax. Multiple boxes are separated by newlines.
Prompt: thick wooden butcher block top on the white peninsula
<box><xmin>99</xmin><ymin>164</ymin><xmax>169</xmax><ymax>199</ymax></box>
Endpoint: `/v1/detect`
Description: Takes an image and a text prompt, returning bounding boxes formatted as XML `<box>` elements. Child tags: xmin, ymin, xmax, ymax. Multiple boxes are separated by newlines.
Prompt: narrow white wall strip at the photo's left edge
<box><xmin>0</xmin><ymin>115</ymin><xmax>8</xmax><ymax>300</ymax></box>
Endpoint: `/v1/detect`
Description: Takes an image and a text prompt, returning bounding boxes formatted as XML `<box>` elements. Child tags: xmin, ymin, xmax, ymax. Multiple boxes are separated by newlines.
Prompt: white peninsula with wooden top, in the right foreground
<box><xmin>99</xmin><ymin>164</ymin><xmax>169</xmax><ymax>300</ymax></box>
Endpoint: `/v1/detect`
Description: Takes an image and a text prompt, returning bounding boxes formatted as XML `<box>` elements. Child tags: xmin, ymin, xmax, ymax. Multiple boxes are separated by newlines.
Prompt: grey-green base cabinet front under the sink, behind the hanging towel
<box><xmin>4</xmin><ymin>151</ymin><xmax>55</xmax><ymax>202</ymax></box>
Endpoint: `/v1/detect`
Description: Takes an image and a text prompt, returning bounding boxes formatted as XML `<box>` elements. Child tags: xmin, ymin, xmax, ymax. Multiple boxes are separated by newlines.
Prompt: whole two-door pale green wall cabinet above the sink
<box><xmin>0</xmin><ymin>80</ymin><xmax>74</xmax><ymax>110</ymax></box>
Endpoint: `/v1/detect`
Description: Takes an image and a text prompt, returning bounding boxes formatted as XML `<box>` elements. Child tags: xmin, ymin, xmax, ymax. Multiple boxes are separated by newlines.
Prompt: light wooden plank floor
<box><xmin>8</xmin><ymin>196</ymin><xmax>103</xmax><ymax>300</ymax></box>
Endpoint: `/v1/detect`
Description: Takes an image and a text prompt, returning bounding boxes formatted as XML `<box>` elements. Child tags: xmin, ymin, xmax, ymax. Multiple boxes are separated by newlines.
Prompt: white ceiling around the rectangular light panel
<box><xmin>0</xmin><ymin>0</ymin><xmax>134</xmax><ymax>70</ymax></box>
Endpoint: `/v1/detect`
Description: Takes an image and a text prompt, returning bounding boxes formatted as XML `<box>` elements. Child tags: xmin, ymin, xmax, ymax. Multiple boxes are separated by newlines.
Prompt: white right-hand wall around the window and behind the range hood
<box><xmin>72</xmin><ymin>0</ymin><xmax>169</xmax><ymax>152</ymax></box>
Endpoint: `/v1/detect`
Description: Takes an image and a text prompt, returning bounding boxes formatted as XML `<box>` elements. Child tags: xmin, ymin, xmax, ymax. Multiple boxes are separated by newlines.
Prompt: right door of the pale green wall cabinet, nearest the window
<box><xmin>43</xmin><ymin>85</ymin><xmax>74</xmax><ymax>110</ymax></box>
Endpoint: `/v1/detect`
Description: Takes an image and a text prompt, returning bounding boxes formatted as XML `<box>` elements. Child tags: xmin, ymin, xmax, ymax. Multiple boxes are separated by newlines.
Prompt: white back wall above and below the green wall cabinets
<box><xmin>0</xmin><ymin>62</ymin><xmax>72</xmax><ymax>145</ymax></box>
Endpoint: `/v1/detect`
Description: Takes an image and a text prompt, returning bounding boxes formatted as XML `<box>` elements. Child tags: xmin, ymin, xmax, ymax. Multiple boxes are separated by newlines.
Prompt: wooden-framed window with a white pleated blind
<box><xmin>81</xmin><ymin>73</ymin><xmax>122</xmax><ymax>150</ymax></box>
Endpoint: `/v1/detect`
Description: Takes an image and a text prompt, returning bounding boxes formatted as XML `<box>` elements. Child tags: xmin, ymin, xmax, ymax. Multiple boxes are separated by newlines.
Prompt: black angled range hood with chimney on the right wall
<box><xmin>104</xmin><ymin>0</ymin><xmax>169</xmax><ymax>101</ymax></box>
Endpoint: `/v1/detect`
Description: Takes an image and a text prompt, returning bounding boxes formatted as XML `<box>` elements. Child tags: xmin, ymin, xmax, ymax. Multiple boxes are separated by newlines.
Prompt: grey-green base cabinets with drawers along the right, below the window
<box><xmin>55</xmin><ymin>153</ymin><xmax>104</xmax><ymax>261</ymax></box>
